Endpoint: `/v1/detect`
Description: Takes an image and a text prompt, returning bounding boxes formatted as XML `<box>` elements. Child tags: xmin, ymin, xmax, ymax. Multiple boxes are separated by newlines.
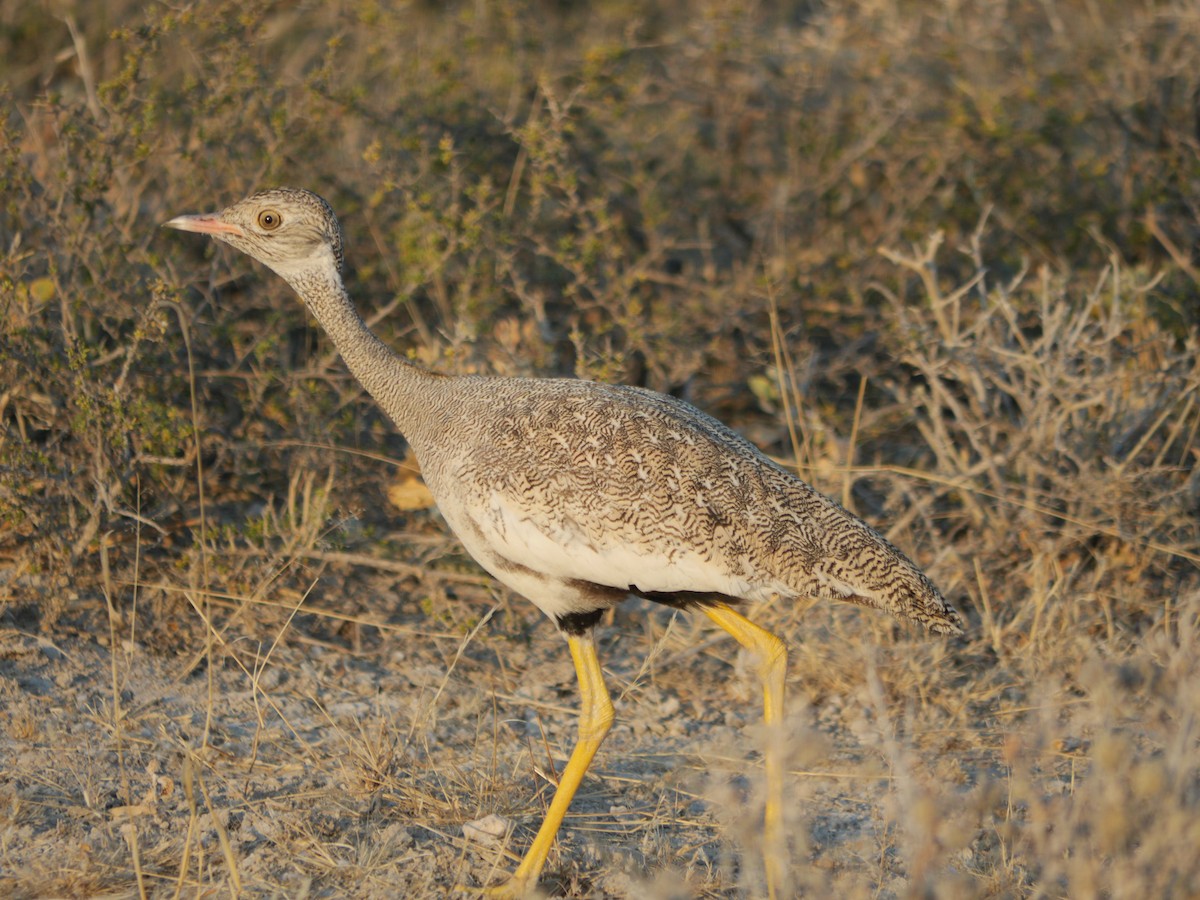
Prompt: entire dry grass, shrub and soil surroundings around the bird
<box><xmin>0</xmin><ymin>0</ymin><xmax>1200</xmax><ymax>900</ymax></box>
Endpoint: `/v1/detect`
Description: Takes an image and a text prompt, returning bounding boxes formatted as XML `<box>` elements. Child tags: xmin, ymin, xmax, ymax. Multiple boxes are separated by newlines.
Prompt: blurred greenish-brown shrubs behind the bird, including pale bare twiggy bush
<box><xmin>0</xmin><ymin>0</ymin><xmax>1200</xmax><ymax>895</ymax></box>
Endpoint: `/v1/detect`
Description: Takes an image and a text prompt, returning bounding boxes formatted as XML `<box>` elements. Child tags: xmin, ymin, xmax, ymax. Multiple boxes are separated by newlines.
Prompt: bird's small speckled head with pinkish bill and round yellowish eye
<box><xmin>163</xmin><ymin>187</ymin><xmax>342</xmax><ymax>286</ymax></box>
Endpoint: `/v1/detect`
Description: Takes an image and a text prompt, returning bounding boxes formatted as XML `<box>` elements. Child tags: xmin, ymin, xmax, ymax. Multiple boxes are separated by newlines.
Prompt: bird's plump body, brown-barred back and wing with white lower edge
<box><xmin>410</xmin><ymin>378</ymin><xmax>960</xmax><ymax>632</ymax></box>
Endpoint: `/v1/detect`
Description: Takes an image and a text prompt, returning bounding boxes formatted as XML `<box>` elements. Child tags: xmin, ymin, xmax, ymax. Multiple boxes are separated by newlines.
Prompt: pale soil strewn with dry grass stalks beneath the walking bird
<box><xmin>0</xmin><ymin>554</ymin><xmax>998</xmax><ymax>898</ymax></box>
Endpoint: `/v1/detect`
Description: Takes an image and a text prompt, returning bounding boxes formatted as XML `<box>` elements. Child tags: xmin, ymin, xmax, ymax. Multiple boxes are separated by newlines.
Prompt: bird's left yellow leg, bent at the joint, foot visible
<box><xmin>485</xmin><ymin>631</ymin><xmax>613</xmax><ymax>898</ymax></box>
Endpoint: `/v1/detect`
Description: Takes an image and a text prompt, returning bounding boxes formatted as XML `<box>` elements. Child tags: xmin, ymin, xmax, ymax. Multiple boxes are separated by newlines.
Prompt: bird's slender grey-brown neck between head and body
<box><xmin>288</xmin><ymin>271</ymin><xmax>445</xmax><ymax>440</ymax></box>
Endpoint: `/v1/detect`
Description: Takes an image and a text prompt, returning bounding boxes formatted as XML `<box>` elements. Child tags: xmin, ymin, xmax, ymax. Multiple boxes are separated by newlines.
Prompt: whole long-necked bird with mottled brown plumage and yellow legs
<box><xmin>164</xmin><ymin>187</ymin><xmax>964</xmax><ymax>898</ymax></box>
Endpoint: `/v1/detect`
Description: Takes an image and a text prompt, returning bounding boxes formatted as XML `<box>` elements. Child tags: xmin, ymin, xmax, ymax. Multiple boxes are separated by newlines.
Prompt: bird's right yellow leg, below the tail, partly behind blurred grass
<box><xmin>704</xmin><ymin>604</ymin><xmax>787</xmax><ymax>900</ymax></box>
